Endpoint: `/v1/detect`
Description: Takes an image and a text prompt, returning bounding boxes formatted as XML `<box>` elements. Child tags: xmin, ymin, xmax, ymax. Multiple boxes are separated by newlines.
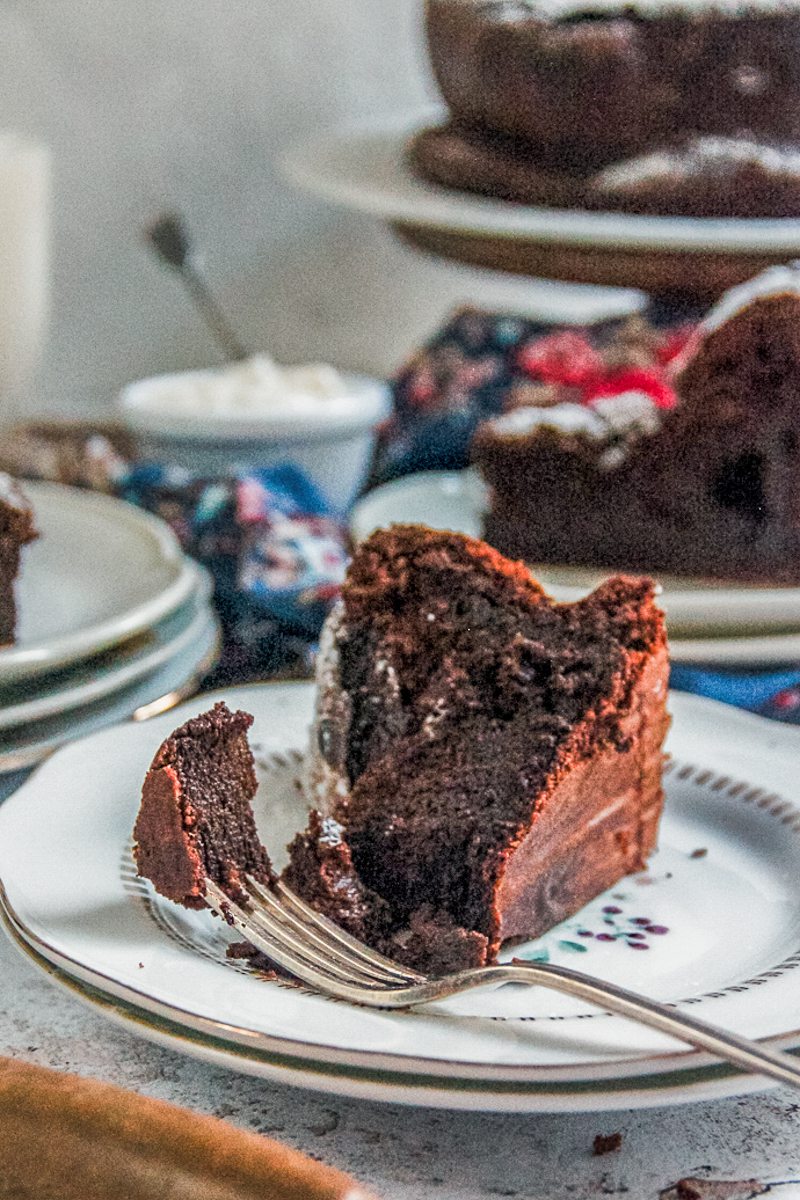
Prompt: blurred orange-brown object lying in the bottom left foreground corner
<box><xmin>0</xmin><ymin>1058</ymin><xmax>369</xmax><ymax>1200</ymax></box>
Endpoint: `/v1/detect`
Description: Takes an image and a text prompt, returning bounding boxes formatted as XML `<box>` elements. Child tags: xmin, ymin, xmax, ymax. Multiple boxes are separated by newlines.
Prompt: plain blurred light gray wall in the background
<box><xmin>0</xmin><ymin>0</ymin><xmax>638</xmax><ymax>414</ymax></box>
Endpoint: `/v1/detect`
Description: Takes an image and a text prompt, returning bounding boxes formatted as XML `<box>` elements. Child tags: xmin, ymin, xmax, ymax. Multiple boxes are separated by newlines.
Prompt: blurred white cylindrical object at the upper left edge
<box><xmin>0</xmin><ymin>131</ymin><xmax>50</xmax><ymax>421</ymax></box>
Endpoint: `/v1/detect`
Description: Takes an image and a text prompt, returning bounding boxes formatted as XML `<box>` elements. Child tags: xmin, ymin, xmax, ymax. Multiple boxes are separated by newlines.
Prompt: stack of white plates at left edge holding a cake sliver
<box><xmin>0</xmin><ymin>484</ymin><xmax>219</xmax><ymax>772</ymax></box>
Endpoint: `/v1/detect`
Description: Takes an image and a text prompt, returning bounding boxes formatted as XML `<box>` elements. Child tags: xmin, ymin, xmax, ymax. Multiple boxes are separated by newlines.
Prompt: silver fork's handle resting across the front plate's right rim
<box><xmin>447</xmin><ymin>962</ymin><xmax>800</xmax><ymax>1087</ymax></box>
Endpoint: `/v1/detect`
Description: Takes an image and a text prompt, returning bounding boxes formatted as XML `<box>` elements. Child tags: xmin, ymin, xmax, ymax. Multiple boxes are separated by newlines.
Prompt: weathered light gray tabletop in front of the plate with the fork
<box><xmin>0</xmin><ymin>780</ymin><xmax>800</xmax><ymax>1200</ymax></box>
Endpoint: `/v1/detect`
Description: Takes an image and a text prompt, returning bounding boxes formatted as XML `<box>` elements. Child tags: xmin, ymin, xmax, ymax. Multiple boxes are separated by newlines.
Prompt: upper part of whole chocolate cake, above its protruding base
<box><xmin>426</xmin><ymin>0</ymin><xmax>800</xmax><ymax>166</ymax></box>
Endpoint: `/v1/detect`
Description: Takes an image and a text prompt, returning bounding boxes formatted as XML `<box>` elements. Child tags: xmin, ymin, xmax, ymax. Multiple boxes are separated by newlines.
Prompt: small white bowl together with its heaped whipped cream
<box><xmin>118</xmin><ymin>354</ymin><xmax>391</xmax><ymax>510</ymax></box>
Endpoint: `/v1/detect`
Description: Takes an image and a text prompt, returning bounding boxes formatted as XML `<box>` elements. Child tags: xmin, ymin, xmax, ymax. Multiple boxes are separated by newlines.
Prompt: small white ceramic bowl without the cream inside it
<box><xmin>118</xmin><ymin>371</ymin><xmax>391</xmax><ymax>512</ymax></box>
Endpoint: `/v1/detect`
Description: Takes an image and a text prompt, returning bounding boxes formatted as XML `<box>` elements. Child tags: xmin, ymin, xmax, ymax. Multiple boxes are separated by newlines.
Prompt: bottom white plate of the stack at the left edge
<box><xmin>0</xmin><ymin>607</ymin><xmax>221</xmax><ymax>774</ymax></box>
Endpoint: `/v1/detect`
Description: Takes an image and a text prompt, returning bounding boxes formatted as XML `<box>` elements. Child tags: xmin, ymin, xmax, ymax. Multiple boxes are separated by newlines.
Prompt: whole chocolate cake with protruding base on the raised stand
<box><xmin>410</xmin><ymin>0</ymin><xmax>800</xmax><ymax>216</ymax></box>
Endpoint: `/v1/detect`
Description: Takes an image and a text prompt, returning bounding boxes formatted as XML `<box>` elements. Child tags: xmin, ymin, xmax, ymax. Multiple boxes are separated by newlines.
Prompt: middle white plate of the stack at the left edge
<box><xmin>0</xmin><ymin>566</ymin><xmax>211</xmax><ymax>730</ymax></box>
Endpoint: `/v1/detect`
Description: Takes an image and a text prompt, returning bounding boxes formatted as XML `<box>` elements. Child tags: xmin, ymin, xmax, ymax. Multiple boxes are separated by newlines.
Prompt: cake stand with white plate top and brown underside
<box><xmin>282</xmin><ymin>109</ymin><xmax>800</xmax><ymax>300</ymax></box>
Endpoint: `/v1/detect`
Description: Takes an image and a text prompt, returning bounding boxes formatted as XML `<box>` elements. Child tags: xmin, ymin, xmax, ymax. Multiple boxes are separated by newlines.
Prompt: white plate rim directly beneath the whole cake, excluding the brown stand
<box><xmin>282</xmin><ymin>109</ymin><xmax>800</xmax><ymax>257</ymax></box>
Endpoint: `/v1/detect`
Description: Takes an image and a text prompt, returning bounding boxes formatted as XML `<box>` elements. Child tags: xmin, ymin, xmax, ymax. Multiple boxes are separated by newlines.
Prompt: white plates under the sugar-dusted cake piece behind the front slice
<box><xmin>350</xmin><ymin>469</ymin><xmax>800</xmax><ymax>661</ymax></box>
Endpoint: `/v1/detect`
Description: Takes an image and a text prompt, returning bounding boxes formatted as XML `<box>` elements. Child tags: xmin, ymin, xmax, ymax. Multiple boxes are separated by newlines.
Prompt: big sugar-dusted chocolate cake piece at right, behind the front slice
<box><xmin>473</xmin><ymin>264</ymin><xmax>800</xmax><ymax>583</ymax></box>
